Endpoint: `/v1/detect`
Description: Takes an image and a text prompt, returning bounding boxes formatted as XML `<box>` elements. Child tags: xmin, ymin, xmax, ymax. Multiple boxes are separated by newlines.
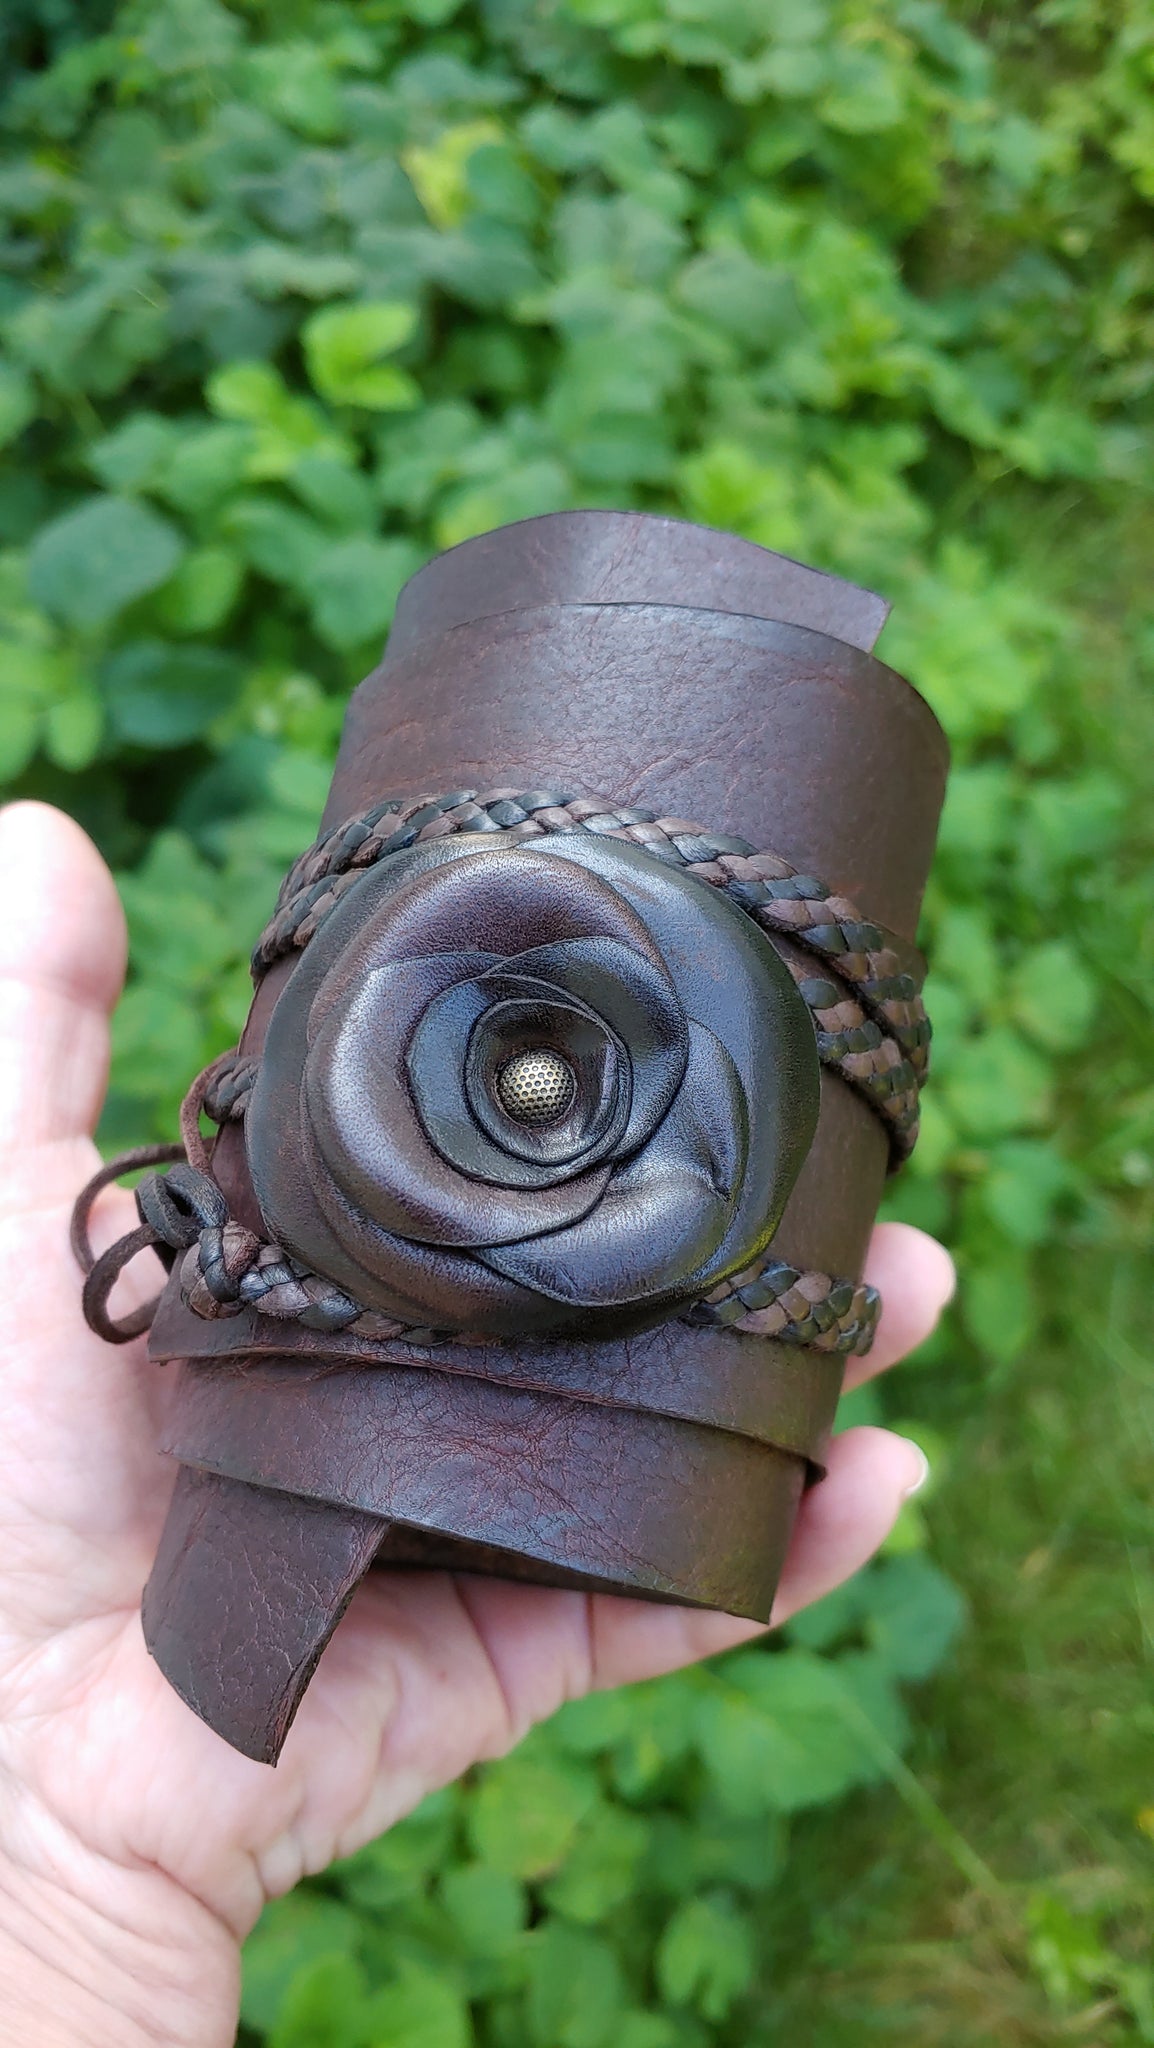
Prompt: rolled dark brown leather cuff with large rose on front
<box><xmin>81</xmin><ymin>512</ymin><xmax>947</xmax><ymax>1761</ymax></box>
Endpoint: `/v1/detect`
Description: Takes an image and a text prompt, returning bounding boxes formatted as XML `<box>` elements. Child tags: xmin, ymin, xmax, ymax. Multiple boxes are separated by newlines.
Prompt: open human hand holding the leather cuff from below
<box><xmin>0</xmin><ymin>805</ymin><xmax>953</xmax><ymax>2048</ymax></box>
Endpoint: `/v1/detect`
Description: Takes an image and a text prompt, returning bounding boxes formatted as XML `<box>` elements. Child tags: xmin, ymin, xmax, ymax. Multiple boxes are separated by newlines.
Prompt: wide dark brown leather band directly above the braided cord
<box><xmin>324</xmin><ymin>606</ymin><xmax>947</xmax><ymax>938</ymax></box>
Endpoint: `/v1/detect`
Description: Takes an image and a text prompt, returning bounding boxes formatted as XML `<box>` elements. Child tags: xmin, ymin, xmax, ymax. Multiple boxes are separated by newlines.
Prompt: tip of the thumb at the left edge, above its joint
<box><xmin>0</xmin><ymin>803</ymin><xmax>125</xmax><ymax>1149</ymax></box>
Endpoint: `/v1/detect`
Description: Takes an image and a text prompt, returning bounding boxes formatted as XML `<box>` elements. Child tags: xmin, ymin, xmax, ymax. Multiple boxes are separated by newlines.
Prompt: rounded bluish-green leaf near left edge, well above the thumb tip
<box><xmin>29</xmin><ymin>498</ymin><xmax>184</xmax><ymax>629</ymax></box>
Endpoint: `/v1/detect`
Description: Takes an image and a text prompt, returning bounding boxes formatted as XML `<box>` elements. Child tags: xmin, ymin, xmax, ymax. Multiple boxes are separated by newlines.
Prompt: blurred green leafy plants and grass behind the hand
<box><xmin>0</xmin><ymin>0</ymin><xmax>1154</xmax><ymax>2048</ymax></box>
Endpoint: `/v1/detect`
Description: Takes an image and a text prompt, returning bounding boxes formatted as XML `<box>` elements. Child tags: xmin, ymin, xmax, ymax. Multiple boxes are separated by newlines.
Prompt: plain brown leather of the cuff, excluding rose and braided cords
<box><xmin>150</xmin><ymin>514</ymin><xmax>947</xmax><ymax>1753</ymax></box>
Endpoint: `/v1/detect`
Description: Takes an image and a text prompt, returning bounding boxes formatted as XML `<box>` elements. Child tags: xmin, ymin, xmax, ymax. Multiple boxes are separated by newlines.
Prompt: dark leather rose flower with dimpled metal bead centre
<box><xmin>246</xmin><ymin>834</ymin><xmax>818</xmax><ymax>1337</ymax></box>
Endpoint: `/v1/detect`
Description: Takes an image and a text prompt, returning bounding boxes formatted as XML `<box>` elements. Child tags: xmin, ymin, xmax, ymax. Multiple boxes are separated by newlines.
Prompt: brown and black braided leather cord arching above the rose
<box><xmin>252</xmin><ymin>791</ymin><xmax>931</xmax><ymax>1163</ymax></box>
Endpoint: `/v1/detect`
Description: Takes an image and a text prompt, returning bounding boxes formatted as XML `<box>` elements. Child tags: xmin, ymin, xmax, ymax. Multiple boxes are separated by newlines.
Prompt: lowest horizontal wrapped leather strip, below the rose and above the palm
<box><xmin>162</xmin><ymin>1362</ymin><xmax>806</xmax><ymax>1624</ymax></box>
